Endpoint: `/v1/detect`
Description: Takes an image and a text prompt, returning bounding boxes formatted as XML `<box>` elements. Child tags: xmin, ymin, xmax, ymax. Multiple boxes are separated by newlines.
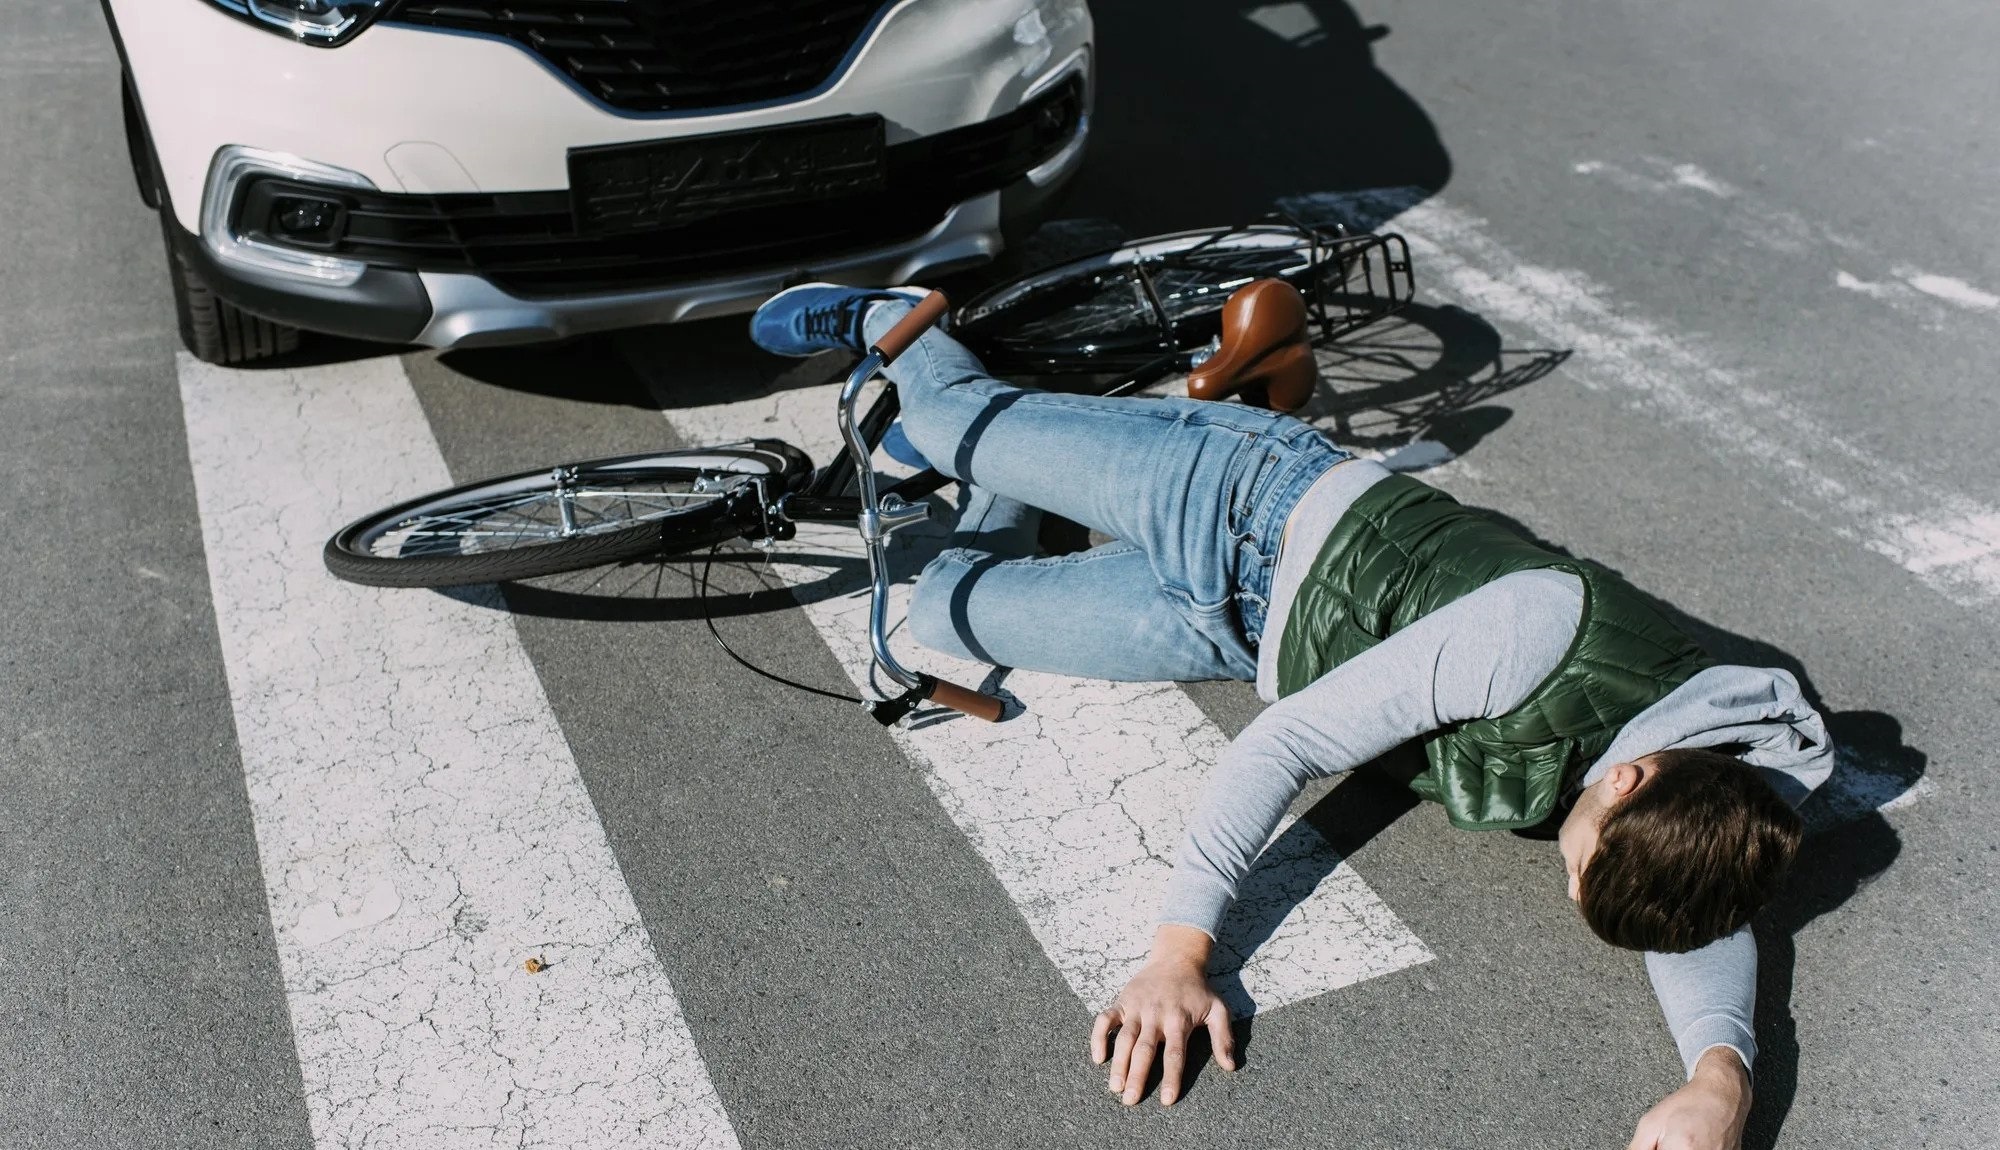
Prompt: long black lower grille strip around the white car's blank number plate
<box><xmin>234</xmin><ymin>78</ymin><xmax>1084</xmax><ymax>298</ymax></box>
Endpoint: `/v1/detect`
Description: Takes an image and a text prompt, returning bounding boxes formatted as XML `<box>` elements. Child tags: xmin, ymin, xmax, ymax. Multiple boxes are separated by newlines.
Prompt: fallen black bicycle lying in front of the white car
<box><xmin>324</xmin><ymin>216</ymin><xmax>1416</xmax><ymax>726</ymax></box>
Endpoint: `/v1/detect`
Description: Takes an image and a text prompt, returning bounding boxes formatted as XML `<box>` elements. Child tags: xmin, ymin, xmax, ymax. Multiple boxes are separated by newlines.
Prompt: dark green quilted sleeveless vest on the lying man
<box><xmin>1278</xmin><ymin>476</ymin><xmax>1710</xmax><ymax>830</ymax></box>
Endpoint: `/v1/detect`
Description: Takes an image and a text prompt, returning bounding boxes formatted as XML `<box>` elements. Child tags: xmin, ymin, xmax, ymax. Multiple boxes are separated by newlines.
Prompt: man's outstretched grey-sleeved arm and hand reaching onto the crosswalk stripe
<box><xmin>1090</xmin><ymin>572</ymin><xmax>1584</xmax><ymax>1104</ymax></box>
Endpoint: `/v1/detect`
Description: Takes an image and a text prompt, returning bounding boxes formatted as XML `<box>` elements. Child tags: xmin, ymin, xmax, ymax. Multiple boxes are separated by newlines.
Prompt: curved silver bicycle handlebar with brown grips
<box><xmin>840</xmin><ymin>292</ymin><xmax>1002</xmax><ymax>726</ymax></box>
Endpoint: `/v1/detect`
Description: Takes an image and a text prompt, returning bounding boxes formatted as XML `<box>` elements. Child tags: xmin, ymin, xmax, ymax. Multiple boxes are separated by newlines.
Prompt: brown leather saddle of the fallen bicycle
<box><xmin>1188</xmin><ymin>280</ymin><xmax>1320</xmax><ymax>412</ymax></box>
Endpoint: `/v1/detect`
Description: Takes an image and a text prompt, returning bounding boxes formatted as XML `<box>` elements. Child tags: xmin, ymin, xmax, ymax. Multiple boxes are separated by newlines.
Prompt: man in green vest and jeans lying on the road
<box><xmin>752</xmin><ymin>280</ymin><xmax>1832</xmax><ymax>1150</ymax></box>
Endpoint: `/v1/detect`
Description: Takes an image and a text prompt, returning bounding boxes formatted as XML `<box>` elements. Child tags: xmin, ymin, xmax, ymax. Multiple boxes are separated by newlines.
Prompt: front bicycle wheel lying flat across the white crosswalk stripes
<box><xmin>322</xmin><ymin>440</ymin><xmax>812</xmax><ymax>588</ymax></box>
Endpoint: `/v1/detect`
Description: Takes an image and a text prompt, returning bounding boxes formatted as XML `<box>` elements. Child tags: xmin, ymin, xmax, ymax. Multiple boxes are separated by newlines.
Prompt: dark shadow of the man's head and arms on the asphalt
<box><xmin>1212</xmin><ymin>508</ymin><xmax>1928</xmax><ymax>1150</ymax></box>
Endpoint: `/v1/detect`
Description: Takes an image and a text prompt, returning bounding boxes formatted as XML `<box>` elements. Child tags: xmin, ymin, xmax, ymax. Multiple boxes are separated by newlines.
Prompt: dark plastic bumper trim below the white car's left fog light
<box><xmin>162</xmin><ymin>220</ymin><xmax>430</xmax><ymax>344</ymax></box>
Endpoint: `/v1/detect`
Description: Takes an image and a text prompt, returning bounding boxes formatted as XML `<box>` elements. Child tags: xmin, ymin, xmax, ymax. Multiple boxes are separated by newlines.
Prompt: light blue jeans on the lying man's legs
<box><xmin>866</xmin><ymin>302</ymin><xmax>1348</xmax><ymax>682</ymax></box>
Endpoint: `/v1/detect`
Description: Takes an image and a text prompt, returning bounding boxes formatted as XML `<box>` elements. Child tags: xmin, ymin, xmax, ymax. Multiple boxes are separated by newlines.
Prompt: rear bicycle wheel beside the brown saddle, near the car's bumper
<box><xmin>952</xmin><ymin>222</ymin><xmax>1374</xmax><ymax>374</ymax></box>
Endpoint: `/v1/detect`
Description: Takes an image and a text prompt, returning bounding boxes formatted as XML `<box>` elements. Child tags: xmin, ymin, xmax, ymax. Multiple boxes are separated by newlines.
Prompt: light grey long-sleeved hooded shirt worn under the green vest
<box><xmin>1160</xmin><ymin>460</ymin><xmax>1830</xmax><ymax>1076</ymax></box>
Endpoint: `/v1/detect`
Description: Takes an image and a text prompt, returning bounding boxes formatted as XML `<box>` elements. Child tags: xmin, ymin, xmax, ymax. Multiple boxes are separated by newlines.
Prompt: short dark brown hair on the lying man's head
<box><xmin>1578</xmin><ymin>750</ymin><xmax>1804</xmax><ymax>952</ymax></box>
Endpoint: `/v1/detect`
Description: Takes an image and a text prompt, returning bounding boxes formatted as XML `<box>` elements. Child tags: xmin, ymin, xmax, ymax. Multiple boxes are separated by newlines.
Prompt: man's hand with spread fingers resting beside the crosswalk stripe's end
<box><xmin>1090</xmin><ymin>924</ymin><xmax>1236</xmax><ymax>1106</ymax></box>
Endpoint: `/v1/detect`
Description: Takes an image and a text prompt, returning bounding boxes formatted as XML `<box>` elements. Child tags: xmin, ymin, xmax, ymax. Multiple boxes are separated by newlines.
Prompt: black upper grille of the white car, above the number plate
<box><xmin>388</xmin><ymin>0</ymin><xmax>886</xmax><ymax>112</ymax></box>
